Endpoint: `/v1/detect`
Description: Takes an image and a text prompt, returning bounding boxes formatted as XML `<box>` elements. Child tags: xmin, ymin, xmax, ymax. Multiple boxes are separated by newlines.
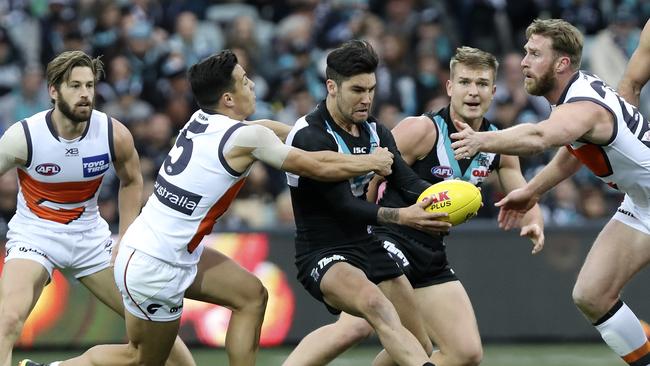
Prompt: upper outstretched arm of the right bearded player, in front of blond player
<box><xmin>451</xmin><ymin>101</ymin><xmax>613</xmax><ymax>160</ymax></box>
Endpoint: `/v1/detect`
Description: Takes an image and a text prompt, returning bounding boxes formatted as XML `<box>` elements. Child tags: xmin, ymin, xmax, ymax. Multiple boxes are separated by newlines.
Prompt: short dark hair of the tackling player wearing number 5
<box><xmin>187</xmin><ymin>50</ymin><xmax>238</xmax><ymax>108</ymax></box>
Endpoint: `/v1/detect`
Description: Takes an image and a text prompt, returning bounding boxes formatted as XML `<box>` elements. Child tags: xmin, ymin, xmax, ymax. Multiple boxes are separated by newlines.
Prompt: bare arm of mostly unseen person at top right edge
<box><xmin>618</xmin><ymin>20</ymin><xmax>650</xmax><ymax>107</ymax></box>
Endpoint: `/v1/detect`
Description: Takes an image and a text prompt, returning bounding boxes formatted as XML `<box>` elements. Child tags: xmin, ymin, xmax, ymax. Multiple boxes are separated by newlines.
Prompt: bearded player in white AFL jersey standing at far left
<box><xmin>0</xmin><ymin>51</ymin><xmax>194</xmax><ymax>366</ymax></box>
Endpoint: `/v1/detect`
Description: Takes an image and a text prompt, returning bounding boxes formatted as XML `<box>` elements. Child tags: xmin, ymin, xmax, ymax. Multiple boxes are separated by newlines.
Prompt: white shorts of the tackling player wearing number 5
<box><xmin>114</xmin><ymin>246</ymin><xmax>197</xmax><ymax>322</ymax></box>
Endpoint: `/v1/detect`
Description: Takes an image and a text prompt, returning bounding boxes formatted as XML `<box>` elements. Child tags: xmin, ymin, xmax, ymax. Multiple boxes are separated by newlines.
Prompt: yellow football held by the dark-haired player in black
<box><xmin>418</xmin><ymin>179</ymin><xmax>483</xmax><ymax>226</ymax></box>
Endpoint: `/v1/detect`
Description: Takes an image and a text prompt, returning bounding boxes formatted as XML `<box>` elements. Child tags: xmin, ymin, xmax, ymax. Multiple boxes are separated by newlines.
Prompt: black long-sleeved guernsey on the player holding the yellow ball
<box><xmin>287</xmin><ymin>101</ymin><xmax>429</xmax><ymax>256</ymax></box>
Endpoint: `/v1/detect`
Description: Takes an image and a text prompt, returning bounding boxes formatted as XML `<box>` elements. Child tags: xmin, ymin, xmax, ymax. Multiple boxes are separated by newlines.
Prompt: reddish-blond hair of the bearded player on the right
<box><xmin>526</xmin><ymin>19</ymin><xmax>584</xmax><ymax>70</ymax></box>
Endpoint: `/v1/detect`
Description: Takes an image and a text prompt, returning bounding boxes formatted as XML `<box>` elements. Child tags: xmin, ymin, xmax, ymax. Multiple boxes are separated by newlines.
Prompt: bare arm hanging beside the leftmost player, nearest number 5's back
<box><xmin>113</xmin><ymin>119</ymin><xmax>142</xmax><ymax>237</ymax></box>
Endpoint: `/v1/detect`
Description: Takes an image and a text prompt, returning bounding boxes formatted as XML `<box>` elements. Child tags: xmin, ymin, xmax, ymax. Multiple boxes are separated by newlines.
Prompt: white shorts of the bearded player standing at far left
<box><xmin>5</xmin><ymin>220</ymin><xmax>113</xmax><ymax>278</ymax></box>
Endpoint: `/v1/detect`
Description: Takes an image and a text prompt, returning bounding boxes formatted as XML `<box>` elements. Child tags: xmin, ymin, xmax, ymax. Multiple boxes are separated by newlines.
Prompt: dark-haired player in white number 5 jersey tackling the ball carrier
<box><xmin>27</xmin><ymin>50</ymin><xmax>393</xmax><ymax>366</ymax></box>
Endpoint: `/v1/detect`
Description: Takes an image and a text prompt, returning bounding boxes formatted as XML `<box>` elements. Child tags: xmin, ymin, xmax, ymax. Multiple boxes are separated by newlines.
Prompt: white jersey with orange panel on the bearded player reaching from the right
<box><xmin>558</xmin><ymin>71</ymin><xmax>650</xmax><ymax>208</ymax></box>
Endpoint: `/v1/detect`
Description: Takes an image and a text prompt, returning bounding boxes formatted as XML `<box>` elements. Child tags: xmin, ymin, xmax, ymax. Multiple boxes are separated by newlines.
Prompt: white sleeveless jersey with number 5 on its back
<box><xmin>122</xmin><ymin>110</ymin><xmax>248</xmax><ymax>266</ymax></box>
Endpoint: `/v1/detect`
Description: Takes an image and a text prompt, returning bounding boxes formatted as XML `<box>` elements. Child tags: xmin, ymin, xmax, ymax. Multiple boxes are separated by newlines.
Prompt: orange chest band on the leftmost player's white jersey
<box><xmin>18</xmin><ymin>169</ymin><xmax>103</xmax><ymax>225</ymax></box>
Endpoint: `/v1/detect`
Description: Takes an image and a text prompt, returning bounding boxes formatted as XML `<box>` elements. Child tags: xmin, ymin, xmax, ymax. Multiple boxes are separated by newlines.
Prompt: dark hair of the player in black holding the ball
<box><xmin>325</xmin><ymin>40</ymin><xmax>379</xmax><ymax>85</ymax></box>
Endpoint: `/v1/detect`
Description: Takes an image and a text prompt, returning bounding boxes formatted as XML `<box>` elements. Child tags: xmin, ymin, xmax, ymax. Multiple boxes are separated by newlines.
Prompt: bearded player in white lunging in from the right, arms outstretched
<box><xmin>451</xmin><ymin>19</ymin><xmax>650</xmax><ymax>365</ymax></box>
